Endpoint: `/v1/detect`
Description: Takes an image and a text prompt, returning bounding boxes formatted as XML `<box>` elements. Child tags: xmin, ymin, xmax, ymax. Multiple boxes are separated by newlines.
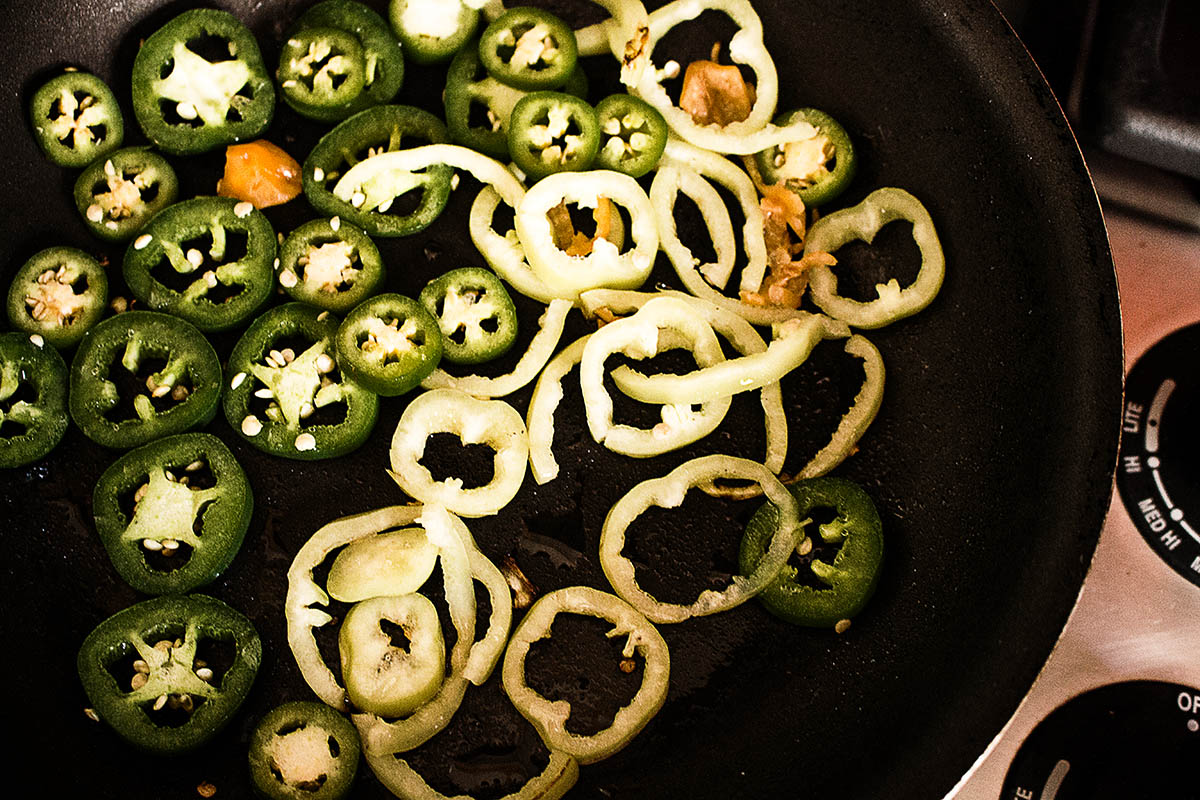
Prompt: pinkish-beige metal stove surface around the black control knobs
<box><xmin>947</xmin><ymin>199</ymin><xmax>1200</xmax><ymax>800</ymax></box>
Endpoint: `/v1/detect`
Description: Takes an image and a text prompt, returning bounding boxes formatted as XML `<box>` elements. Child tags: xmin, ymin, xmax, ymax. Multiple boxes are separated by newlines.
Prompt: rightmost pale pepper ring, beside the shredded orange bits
<box><xmin>804</xmin><ymin>186</ymin><xmax>946</xmax><ymax>329</ymax></box>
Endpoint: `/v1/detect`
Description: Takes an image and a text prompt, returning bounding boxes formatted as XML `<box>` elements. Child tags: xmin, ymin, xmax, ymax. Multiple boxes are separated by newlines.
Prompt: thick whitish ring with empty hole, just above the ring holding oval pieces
<box><xmin>389</xmin><ymin>389</ymin><xmax>529</xmax><ymax>517</ymax></box>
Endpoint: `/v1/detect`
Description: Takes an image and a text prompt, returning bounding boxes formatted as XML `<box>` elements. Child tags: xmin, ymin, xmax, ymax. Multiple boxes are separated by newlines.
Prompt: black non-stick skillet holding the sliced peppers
<box><xmin>0</xmin><ymin>0</ymin><xmax>1121</xmax><ymax>799</ymax></box>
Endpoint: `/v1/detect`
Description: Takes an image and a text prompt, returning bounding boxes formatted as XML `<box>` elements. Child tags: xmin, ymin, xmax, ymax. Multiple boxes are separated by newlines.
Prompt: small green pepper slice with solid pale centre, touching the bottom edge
<box><xmin>243</xmin><ymin>700</ymin><xmax>362</xmax><ymax>800</ymax></box>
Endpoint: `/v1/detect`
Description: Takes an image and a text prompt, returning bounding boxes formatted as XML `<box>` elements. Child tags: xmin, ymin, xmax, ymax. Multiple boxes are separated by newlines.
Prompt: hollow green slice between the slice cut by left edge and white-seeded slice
<box><xmin>70</xmin><ymin>311</ymin><xmax>221</xmax><ymax>450</ymax></box>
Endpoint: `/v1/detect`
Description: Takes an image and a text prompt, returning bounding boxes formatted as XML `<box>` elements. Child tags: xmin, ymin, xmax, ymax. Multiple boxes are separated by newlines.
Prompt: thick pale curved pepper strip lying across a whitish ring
<box><xmin>612</xmin><ymin>314</ymin><xmax>850</xmax><ymax>403</ymax></box>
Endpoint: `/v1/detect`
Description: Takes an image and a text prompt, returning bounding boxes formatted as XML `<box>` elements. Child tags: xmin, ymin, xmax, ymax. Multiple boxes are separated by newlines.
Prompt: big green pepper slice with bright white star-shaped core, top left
<box><xmin>132</xmin><ymin>8</ymin><xmax>275</xmax><ymax>156</ymax></box>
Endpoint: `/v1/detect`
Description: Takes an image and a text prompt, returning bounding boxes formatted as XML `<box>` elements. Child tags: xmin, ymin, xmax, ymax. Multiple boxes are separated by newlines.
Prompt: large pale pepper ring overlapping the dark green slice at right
<box><xmin>600</xmin><ymin>456</ymin><xmax>804</xmax><ymax>624</ymax></box>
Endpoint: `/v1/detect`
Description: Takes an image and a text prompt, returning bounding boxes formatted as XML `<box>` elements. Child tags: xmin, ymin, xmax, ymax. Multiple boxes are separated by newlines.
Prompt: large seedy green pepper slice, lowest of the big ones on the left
<box><xmin>77</xmin><ymin>595</ymin><xmax>263</xmax><ymax>756</ymax></box>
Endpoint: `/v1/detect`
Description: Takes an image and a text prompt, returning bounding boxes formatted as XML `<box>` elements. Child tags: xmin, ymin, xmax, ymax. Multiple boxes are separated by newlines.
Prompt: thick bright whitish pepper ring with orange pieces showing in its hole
<box><xmin>515</xmin><ymin>169</ymin><xmax>659</xmax><ymax>295</ymax></box>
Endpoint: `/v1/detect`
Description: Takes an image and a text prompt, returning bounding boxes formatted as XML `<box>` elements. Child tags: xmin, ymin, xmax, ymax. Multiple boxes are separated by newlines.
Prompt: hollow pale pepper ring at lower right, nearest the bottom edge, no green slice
<box><xmin>500</xmin><ymin>587</ymin><xmax>671</xmax><ymax>764</ymax></box>
